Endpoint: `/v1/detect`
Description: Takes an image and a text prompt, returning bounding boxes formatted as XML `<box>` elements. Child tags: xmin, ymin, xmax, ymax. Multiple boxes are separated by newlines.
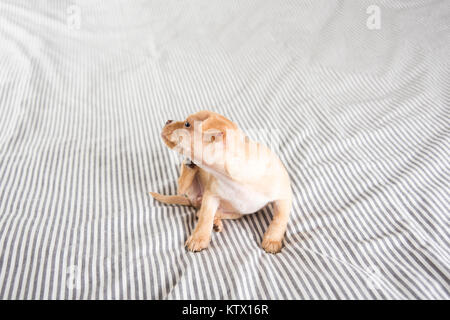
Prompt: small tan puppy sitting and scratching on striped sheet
<box><xmin>150</xmin><ymin>110</ymin><xmax>292</xmax><ymax>253</ymax></box>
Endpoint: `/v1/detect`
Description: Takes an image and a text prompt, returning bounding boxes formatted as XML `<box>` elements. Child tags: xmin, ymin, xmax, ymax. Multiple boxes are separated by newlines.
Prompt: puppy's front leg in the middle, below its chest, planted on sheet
<box><xmin>185</xmin><ymin>192</ymin><xmax>219</xmax><ymax>251</ymax></box>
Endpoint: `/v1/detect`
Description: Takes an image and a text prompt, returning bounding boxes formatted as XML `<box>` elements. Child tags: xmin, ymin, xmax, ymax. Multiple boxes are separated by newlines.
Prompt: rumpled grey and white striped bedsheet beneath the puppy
<box><xmin>0</xmin><ymin>0</ymin><xmax>450</xmax><ymax>299</ymax></box>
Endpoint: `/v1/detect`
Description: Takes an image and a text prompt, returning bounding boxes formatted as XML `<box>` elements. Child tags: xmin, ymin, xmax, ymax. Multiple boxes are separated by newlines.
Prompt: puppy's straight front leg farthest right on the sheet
<box><xmin>262</xmin><ymin>199</ymin><xmax>292</xmax><ymax>253</ymax></box>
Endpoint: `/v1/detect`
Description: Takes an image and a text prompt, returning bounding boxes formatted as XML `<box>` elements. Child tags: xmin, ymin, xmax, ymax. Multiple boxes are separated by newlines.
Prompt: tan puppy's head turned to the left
<box><xmin>161</xmin><ymin>110</ymin><xmax>238</xmax><ymax>166</ymax></box>
